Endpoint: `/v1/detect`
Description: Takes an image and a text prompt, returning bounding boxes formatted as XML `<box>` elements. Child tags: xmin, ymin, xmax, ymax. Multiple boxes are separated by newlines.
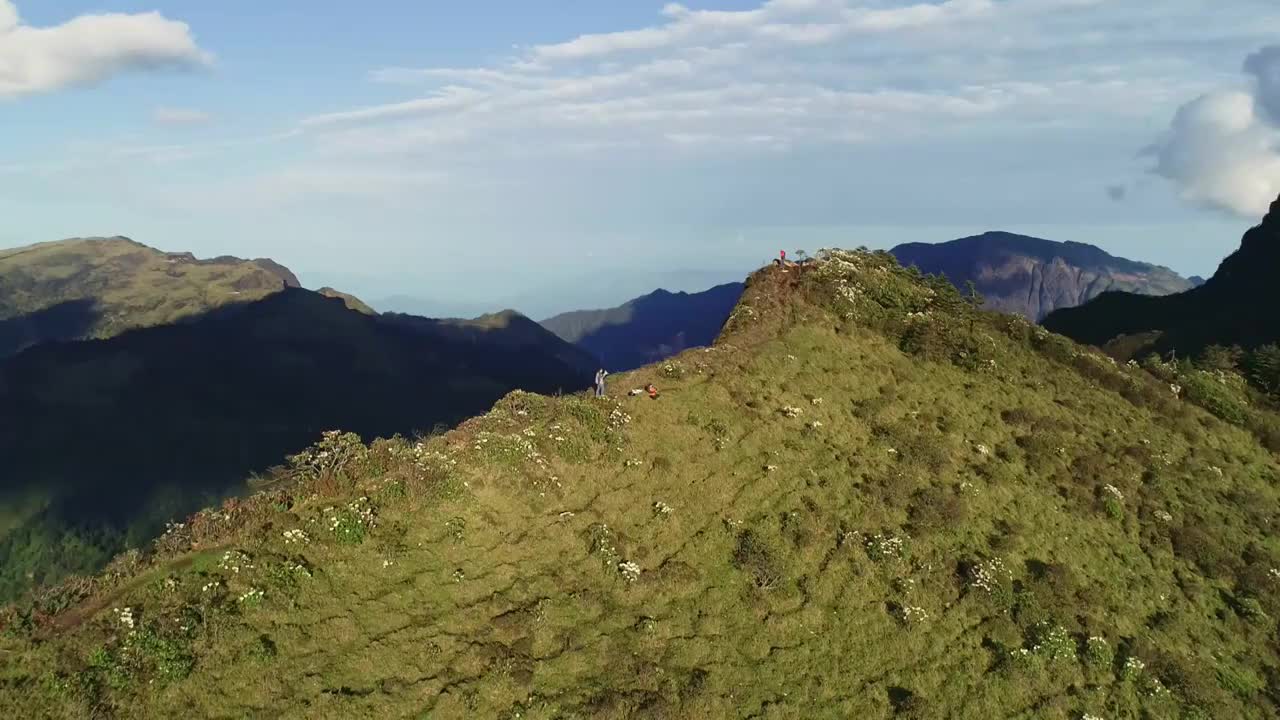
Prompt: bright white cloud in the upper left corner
<box><xmin>0</xmin><ymin>0</ymin><xmax>212</xmax><ymax>99</ymax></box>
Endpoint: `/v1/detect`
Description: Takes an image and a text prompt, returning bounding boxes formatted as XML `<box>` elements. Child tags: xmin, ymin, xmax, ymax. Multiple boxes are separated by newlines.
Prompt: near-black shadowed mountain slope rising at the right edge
<box><xmin>1044</xmin><ymin>193</ymin><xmax>1280</xmax><ymax>357</ymax></box>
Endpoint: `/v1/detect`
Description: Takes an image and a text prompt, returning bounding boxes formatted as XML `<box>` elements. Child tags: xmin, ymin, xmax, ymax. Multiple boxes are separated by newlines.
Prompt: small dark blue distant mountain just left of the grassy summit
<box><xmin>543</xmin><ymin>283</ymin><xmax>742</xmax><ymax>370</ymax></box>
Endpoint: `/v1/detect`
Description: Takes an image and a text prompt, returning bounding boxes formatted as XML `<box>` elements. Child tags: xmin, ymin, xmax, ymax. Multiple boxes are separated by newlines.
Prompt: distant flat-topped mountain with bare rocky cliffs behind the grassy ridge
<box><xmin>890</xmin><ymin>232</ymin><xmax>1196</xmax><ymax>322</ymax></box>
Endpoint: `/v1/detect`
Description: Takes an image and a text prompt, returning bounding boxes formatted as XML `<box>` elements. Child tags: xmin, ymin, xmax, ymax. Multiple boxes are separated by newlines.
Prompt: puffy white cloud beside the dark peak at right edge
<box><xmin>1146</xmin><ymin>47</ymin><xmax>1280</xmax><ymax>218</ymax></box>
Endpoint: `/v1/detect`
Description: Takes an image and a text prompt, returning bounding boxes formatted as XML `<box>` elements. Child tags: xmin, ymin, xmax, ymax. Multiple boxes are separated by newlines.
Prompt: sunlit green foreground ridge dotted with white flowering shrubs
<box><xmin>0</xmin><ymin>252</ymin><xmax>1280</xmax><ymax>720</ymax></box>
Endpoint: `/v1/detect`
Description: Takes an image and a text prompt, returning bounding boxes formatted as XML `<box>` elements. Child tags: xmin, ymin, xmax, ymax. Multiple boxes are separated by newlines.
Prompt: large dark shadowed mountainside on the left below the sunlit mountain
<box><xmin>0</xmin><ymin>288</ymin><xmax>590</xmax><ymax>598</ymax></box>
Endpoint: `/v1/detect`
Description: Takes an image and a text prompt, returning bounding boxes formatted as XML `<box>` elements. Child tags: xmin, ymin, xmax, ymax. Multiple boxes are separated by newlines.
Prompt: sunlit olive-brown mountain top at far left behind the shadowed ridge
<box><xmin>0</xmin><ymin>237</ymin><xmax>298</xmax><ymax>357</ymax></box>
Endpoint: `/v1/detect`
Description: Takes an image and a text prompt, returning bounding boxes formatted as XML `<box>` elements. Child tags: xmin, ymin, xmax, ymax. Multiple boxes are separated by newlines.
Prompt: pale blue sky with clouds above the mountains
<box><xmin>0</xmin><ymin>0</ymin><xmax>1280</xmax><ymax>316</ymax></box>
